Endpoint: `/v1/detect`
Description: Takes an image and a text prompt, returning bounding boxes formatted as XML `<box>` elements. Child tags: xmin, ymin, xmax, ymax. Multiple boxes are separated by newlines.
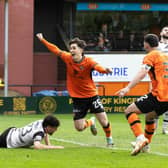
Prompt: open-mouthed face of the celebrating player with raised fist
<box><xmin>70</xmin><ymin>43</ymin><xmax>83</xmax><ymax>62</ymax></box>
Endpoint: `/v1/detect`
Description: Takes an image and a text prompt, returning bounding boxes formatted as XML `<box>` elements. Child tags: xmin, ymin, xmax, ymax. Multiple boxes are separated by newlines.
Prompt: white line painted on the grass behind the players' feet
<box><xmin>50</xmin><ymin>138</ymin><xmax>168</xmax><ymax>156</ymax></box>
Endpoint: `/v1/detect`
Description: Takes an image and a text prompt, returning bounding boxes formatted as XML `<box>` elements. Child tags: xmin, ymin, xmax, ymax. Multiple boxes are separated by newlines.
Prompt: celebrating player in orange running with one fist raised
<box><xmin>36</xmin><ymin>33</ymin><xmax>113</xmax><ymax>146</ymax></box>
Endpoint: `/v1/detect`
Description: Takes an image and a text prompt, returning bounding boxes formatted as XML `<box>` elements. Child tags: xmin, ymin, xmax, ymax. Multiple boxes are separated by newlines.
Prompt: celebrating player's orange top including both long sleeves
<box><xmin>42</xmin><ymin>39</ymin><xmax>107</xmax><ymax>98</ymax></box>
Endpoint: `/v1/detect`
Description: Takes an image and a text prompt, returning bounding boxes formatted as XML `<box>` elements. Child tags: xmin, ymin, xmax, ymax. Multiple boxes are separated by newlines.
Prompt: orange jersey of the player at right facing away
<box><xmin>143</xmin><ymin>50</ymin><xmax>168</xmax><ymax>101</ymax></box>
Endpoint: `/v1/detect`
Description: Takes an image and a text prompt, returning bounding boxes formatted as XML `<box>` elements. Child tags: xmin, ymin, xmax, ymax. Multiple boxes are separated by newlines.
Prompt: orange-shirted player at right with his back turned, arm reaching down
<box><xmin>117</xmin><ymin>34</ymin><xmax>168</xmax><ymax>155</ymax></box>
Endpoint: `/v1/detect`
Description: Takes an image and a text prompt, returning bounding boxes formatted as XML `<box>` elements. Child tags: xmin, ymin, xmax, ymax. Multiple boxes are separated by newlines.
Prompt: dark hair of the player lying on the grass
<box><xmin>42</xmin><ymin>115</ymin><xmax>60</xmax><ymax>128</ymax></box>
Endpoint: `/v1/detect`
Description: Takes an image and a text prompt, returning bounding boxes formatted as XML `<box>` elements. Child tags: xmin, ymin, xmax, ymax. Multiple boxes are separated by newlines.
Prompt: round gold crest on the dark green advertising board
<box><xmin>39</xmin><ymin>97</ymin><xmax>57</xmax><ymax>113</ymax></box>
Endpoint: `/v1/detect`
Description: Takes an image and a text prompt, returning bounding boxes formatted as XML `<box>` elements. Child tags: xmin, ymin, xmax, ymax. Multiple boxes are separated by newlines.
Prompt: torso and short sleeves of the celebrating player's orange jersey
<box><xmin>61</xmin><ymin>54</ymin><xmax>97</xmax><ymax>98</ymax></box>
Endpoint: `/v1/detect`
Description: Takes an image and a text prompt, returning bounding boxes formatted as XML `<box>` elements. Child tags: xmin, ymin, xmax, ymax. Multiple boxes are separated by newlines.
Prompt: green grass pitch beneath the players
<box><xmin>0</xmin><ymin>114</ymin><xmax>168</xmax><ymax>168</ymax></box>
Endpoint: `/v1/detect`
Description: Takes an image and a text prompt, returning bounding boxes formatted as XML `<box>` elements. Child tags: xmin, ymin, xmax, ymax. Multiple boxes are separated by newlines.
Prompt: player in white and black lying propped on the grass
<box><xmin>0</xmin><ymin>115</ymin><xmax>64</xmax><ymax>149</ymax></box>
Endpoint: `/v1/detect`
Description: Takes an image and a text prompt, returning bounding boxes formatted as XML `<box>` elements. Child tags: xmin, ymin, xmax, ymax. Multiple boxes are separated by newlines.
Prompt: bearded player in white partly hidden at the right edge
<box><xmin>156</xmin><ymin>26</ymin><xmax>168</xmax><ymax>134</ymax></box>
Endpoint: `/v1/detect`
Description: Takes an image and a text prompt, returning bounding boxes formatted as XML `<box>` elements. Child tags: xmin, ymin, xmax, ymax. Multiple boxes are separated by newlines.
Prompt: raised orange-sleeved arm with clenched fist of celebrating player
<box><xmin>36</xmin><ymin>33</ymin><xmax>63</xmax><ymax>56</ymax></box>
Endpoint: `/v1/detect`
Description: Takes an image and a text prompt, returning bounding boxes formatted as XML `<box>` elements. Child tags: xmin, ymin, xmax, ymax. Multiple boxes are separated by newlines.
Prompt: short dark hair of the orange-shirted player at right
<box><xmin>144</xmin><ymin>34</ymin><xmax>159</xmax><ymax>47</ymax></box>
